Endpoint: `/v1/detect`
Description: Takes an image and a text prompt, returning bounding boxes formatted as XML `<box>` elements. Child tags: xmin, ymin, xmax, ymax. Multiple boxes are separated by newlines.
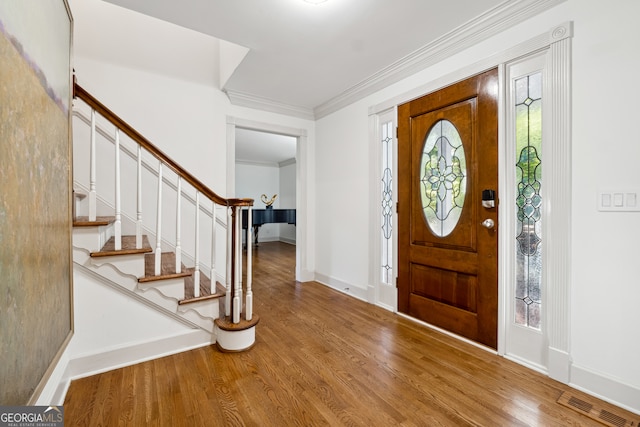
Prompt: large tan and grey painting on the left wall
<box><xmin>0</xmin><ymin>0</ymin><xmax>73</xmax><ymax>405</ymax></box>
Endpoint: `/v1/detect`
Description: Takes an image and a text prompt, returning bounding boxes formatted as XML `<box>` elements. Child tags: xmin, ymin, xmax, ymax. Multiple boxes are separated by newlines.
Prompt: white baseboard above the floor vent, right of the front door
<box><xmin>569</xmin><ymin>364</ymin><xmax>640</xmax><ymax>415</ymax></box>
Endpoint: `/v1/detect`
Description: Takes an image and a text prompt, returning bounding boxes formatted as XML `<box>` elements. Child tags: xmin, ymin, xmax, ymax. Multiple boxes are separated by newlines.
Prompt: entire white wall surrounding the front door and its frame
<box><xmin>315</xmin><ymin>0</ymin><xmax>640</xmax><ymax>411</ymax></box>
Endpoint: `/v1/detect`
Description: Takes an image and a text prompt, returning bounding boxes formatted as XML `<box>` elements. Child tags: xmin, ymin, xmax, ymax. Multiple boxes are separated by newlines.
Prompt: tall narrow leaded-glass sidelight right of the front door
<box><xmin>515</xmin><ymin>73</ymin><xmax>542</xmax><ymax>329</ymax></box>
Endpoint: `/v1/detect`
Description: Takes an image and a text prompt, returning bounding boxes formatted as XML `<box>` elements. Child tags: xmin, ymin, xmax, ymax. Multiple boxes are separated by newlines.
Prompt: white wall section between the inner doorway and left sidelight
<box><xmin>315</xmin><ymin>102</ymin><xmax>376</xmax><ymax>299</ymax></box>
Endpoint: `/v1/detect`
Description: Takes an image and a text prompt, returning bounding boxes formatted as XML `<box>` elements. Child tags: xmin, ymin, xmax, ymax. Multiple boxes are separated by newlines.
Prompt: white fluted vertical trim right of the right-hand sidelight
<box><xmin>542</xmin><ymin>22</ymin><xmax>573</xmax><ymax>384</ymax></box>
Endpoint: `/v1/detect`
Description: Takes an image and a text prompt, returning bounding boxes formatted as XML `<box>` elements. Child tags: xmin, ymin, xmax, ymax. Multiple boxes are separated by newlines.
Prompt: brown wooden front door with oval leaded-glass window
<box><xmin>398</xmin><ymin>70</ymin><xmax>498</xmax><ymax>349</ymax></box>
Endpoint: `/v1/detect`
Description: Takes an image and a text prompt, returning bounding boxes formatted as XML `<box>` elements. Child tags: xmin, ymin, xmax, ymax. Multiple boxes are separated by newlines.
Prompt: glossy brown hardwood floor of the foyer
<box><xmin>64</xmin><ymin>243</ymin><xmax>638</xmax><ymax>426</ymax></box>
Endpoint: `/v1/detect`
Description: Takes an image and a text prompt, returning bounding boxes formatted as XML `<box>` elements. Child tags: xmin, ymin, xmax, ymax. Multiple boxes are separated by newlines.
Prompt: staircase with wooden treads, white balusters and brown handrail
<box><xmin>73</xmin><ymin>84</ymin><xmax>259</xmax><ymax>352</ymax></box>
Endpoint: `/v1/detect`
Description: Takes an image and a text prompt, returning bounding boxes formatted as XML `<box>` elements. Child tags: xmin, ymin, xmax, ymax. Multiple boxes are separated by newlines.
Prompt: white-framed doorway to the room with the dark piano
<box><xmin>227</xmin><ymin>117</ymin><xmax>311</xmax><ymax>281</ymax></box>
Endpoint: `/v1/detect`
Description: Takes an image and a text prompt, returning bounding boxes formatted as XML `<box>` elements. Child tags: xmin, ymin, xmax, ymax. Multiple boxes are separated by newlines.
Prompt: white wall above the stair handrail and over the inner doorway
<box><xmin>69</xmin><ymin>0</ymin><xmax>314</xmax><ymax>197</ymax></box>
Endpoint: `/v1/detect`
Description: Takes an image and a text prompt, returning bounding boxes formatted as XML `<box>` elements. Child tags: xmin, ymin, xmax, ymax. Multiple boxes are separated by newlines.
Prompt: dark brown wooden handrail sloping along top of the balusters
<box><xmin>73</xmin><ymin>81</ymin><xmax>253</xmax><ymax>207</ymax></box>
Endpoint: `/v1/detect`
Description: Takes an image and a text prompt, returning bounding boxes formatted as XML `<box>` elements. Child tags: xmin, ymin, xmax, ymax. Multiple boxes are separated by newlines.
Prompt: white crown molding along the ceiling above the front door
<box><xmin>313</xmin><ymin>0</ymin><xmax>567</xmax><ymax>119</ymax></box>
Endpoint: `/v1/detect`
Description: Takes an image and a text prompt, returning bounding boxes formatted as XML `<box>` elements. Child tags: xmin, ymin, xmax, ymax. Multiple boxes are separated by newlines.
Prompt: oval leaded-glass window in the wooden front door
<box><xmin>419</xmin><ymin>120</ymin><xmax>467</xmax><ymax>237</ymax></box>
